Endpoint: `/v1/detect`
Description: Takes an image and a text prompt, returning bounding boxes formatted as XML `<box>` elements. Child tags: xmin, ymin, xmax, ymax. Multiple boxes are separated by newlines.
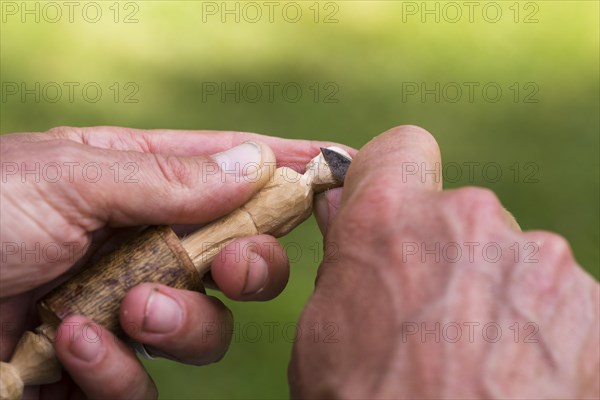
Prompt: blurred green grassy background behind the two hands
<box><xmin>0</xmin><ymin>0</ymin><xmax>600</xmax><ymax>399</ymax></box>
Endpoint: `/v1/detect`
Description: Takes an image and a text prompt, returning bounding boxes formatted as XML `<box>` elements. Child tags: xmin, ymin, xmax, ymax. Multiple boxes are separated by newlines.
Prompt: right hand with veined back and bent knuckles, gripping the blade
<box><xmin>289</xmin><ymin>126</ymin><xmax>600</xmax><ymax>399</ymax></box>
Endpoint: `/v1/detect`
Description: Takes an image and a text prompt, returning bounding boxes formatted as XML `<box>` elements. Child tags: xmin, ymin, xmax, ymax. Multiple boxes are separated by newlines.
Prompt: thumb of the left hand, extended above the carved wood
<box><xmin>66</xmin><ymin>142</ymin><xmax>276</xmax><ymax>231</ymax></box>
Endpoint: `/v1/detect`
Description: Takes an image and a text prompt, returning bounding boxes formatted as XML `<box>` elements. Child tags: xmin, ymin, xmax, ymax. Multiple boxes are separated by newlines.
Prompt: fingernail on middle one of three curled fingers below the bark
<box><xmin>142</xmin><ymin>289</ymin><xmax>183</xmax><ymax>333</ymax></box>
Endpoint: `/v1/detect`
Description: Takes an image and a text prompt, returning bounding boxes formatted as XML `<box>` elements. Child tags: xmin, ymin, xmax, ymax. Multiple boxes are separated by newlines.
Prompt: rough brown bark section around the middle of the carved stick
<box><xmin>39</xmin><ymin>226</ymin><xmax>202</xmax><ymax>336</ymax></box>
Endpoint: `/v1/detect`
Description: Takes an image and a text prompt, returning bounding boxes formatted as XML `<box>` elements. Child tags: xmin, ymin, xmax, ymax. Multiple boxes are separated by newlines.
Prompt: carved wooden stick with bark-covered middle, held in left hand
<box><xmin>0</xmin><ymin>148</ymin><xmax>350</xmax><ymax>400</ymax></box>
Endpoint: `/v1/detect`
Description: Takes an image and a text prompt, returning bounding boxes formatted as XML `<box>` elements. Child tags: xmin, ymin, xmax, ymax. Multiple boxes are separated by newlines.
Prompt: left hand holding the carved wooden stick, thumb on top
<box><xmin>0</xmin><ymin>127</ymin><xmax>352</xmax><ymax>398</ymax></box>
